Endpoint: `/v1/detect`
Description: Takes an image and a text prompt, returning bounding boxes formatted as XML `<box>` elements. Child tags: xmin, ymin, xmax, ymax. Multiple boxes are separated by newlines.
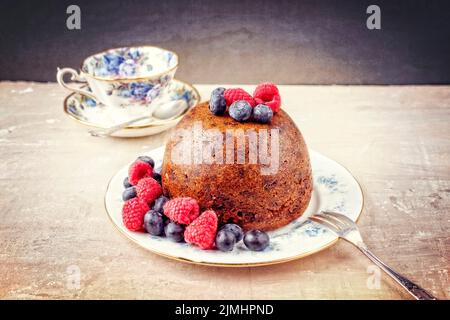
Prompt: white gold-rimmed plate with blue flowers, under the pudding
<box><xmin>105</xmin><ymin>147</ymin><xmax>363</xmax><ymax>267</ymax></box>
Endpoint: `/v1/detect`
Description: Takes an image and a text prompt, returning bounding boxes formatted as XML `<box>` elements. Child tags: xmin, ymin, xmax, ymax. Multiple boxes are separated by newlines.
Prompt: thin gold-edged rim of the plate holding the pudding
<box><xmin>103</xmin><ymin>154</ymin><xmax>364</xmax><ymax>268</ymax></box>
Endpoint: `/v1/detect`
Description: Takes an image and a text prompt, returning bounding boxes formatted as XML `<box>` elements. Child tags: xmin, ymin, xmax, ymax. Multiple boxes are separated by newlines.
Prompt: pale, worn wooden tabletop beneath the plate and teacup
<box><xmin>0</xmin><ymin>82</ymin><xmax>450</xmax><ymax>299</ymax></box>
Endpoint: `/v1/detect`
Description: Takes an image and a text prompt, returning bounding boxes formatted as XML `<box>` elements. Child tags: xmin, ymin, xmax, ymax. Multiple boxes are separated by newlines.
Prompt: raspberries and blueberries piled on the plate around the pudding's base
<box><xmin>122</xmin><ymin>156</ymin><xmax>269</xmax><ymax>251</ymax></box>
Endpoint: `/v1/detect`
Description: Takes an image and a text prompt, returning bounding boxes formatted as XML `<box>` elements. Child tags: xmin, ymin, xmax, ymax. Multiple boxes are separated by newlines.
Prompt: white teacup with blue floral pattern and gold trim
<box><xmin>56</xmin><ymin>46</ymin><xmax>178</xmax><ymax>107</ymax></box>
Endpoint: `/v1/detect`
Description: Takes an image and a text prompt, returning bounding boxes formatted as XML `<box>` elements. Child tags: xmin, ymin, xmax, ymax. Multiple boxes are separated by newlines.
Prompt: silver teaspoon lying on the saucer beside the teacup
<box><xmin>88</xmin><ymin>100</ymin><xmax>189</xmax><ymax>137</ymax></box>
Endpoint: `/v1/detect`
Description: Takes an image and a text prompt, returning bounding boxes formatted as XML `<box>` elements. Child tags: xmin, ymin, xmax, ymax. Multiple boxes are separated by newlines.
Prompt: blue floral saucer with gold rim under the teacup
<box><xmin>64</xmin><ymin>79</ymin><xmax>200</xmax><ymax>137</ymax></box>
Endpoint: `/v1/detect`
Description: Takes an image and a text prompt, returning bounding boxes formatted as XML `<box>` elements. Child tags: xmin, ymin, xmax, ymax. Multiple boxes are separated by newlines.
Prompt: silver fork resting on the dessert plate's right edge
<box><xmin>309</xmin><ymin>212</ymin><xmax>437</xmax><ymax>300</ymax></box>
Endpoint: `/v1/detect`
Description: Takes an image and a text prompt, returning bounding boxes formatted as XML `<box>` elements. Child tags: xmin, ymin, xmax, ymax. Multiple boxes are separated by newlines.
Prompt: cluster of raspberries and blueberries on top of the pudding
<box><xmin>209</xmin><ymin>82</ymin><xmax>281</xmax><ymax>123</ymax></box>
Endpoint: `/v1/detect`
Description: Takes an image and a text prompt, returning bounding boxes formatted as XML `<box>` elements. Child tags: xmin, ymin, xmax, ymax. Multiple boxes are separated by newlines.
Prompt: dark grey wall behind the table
<box><xmin>0</xmin><ymin>0</ymin><xmax>450</xmax><ymax>84</ymax></box>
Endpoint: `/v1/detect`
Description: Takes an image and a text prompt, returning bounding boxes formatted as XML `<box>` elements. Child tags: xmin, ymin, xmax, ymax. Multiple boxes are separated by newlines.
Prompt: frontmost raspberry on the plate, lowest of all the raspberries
<box><xmin>184</xmin><ymin>210</ymin><xmax>217</xmax><ymax>249</ymax></box>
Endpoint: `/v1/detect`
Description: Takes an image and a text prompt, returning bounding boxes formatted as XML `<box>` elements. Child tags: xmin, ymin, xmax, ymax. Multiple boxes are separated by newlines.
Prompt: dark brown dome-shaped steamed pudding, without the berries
<box><xmin>161</xmin><ymin>102</ymin><xmax>312</xmax><ymax>230</ymax></box>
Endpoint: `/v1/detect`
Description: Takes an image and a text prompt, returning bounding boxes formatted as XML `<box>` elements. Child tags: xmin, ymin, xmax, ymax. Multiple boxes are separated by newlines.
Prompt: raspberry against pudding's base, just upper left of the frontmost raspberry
<box><xmin>163</xmin><ymin>197</ymin><xmax>200</xmax><ymax>224</ymax></box>
